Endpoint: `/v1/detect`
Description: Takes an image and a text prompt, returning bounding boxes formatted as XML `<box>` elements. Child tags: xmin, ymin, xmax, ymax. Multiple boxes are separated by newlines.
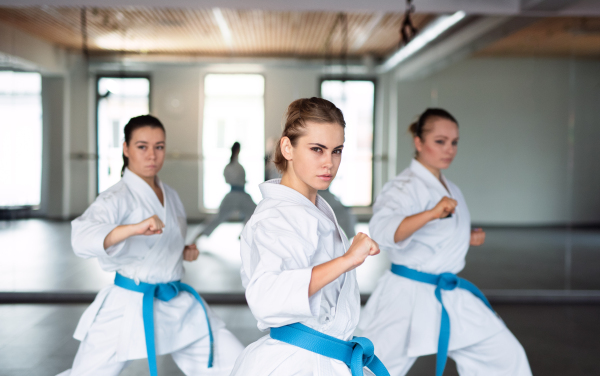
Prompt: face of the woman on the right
<box><xmin>414</xmin><ymin>118</ymin><xmax>458</xmax><ymax>170</ymax></box>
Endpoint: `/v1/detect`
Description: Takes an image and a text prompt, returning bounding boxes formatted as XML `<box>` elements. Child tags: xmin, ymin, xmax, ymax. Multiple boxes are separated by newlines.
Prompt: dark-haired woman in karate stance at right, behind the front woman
<box><xmin>359</xmin><ymin>108</ymin><xmax>531</xmax><ymax>376</ymax></box>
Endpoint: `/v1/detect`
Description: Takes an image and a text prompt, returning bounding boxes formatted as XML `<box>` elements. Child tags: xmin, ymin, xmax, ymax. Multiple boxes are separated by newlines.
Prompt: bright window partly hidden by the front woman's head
<box><xmin>321</xmin><ymin>80</ymin><xmax>375</xmax><ymax>206</ymax></box>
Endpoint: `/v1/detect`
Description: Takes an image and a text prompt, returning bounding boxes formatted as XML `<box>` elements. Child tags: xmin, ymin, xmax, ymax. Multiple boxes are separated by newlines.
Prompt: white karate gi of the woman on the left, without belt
<box><xmin>61</xmin><ymin>169</ymin><xmax>243</xmax><ymax>376</ymax></box>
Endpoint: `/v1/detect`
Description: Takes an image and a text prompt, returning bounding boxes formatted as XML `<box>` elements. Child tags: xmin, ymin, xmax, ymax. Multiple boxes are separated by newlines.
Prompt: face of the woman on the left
<box><xmin>123</xmin><ymin>126</ymin><xmax>165</xmax><ymax>178</ymax></box>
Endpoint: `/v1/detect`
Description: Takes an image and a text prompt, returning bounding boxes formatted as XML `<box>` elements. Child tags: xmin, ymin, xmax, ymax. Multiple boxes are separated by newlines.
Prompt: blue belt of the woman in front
<box><xmin>271</xmin><ymin>323</ymin><xmax>390</xmax><ymax>376</ymax></box>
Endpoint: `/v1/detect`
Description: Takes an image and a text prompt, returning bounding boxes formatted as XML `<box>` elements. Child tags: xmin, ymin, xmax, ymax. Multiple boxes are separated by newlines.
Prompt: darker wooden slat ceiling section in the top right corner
<box><xmin>478</xmin><ymin>17</ymin><xmax>600</xmax><ymax>58</ymax></box>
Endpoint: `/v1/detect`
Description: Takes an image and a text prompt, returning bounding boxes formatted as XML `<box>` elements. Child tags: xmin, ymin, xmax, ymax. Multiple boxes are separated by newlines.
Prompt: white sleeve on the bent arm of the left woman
<box><xmin>71</xmin><ymin>194</ymin><xmax>127</xmax><ymax>259</ymax></box>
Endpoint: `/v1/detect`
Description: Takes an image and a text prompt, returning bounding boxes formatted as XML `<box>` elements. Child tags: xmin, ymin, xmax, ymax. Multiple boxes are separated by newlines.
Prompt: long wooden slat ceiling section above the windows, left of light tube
<box><xmin>0</xmin><ymin>5</ymin><xmax>432</xmax><ymax>58</ymax></box>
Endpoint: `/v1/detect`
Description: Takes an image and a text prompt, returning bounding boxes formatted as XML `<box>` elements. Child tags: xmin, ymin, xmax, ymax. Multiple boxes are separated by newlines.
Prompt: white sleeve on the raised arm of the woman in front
<box><xmin>245</xmin><ymin>218</ymin><xmax>321</xmax><ymax>327</ymax></box>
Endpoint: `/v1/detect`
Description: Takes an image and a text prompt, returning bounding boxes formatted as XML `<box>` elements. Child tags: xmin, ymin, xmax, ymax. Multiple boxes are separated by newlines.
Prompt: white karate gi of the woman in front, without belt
<box><xmin>232</xmin><ymin>179</ymin><xmax>371</xmax><ymax>376</ymax></box>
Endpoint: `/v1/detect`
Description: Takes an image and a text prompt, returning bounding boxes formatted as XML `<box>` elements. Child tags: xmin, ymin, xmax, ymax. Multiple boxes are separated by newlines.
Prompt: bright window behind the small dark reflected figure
<box><xmin>202</xmin><ymin>74</ymin><xmax>265</xmax><ymax>209</ymax></box>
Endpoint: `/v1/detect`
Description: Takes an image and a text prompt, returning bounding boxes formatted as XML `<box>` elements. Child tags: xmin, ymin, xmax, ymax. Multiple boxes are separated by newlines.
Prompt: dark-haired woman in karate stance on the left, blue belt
<box><xmin>61</xmin><ymin>115</ymin><xmax>243</xmax><ymax>376</ymax></box>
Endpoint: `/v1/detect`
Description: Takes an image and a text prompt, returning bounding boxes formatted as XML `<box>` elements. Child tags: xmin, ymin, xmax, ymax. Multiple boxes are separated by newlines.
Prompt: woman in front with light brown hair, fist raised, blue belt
<box><xmin>232</xmin><ymin>98</ymin><xmax>388</xmax><ymax>376</ymax></box>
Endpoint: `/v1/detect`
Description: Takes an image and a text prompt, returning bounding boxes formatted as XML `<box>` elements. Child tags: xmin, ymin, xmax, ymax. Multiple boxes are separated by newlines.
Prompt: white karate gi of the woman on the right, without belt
<box><xmin>359</xmin><ymin>160</ymin><xmax>531</xmax><ymax>376</ymax></box>
